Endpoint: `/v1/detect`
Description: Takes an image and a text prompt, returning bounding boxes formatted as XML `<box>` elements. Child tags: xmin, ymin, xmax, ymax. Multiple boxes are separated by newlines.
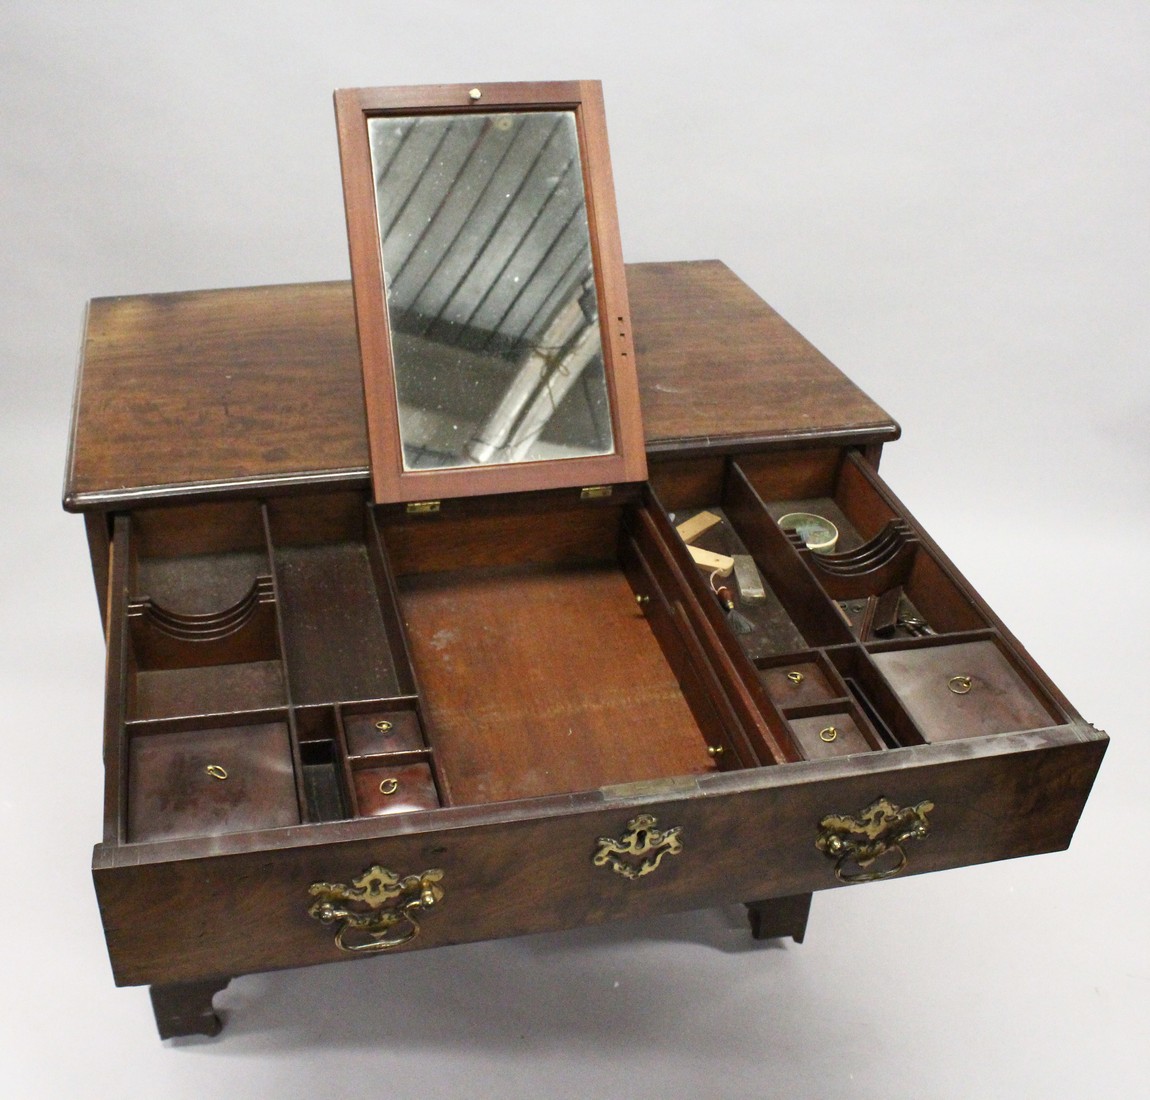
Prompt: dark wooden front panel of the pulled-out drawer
<box><xmin>94</xmin><ymin>726</ymin><xmax>1105</xmax><ymax>985</ymax></box>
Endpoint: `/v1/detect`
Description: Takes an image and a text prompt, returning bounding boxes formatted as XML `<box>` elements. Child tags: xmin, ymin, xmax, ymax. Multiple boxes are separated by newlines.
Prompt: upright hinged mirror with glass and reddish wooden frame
<box><xmin>336</xmin><ymin>82</ymin><xmax>646</xmax><ymax>502</ymax></box>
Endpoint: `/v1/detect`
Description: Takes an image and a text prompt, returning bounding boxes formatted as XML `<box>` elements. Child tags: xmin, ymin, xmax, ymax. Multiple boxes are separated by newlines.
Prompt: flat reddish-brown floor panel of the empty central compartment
<box><xmin>400</xmin><ymin>567</ymin><xmax>714</xmax><ymax>803</ymax></box>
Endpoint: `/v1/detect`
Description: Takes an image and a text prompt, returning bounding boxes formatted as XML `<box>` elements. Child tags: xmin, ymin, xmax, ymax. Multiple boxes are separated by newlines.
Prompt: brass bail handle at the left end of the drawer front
<box><xmin>307</xmin><ymin>863</ymin><xmax>444</xmax><ymax>952</ymax></box>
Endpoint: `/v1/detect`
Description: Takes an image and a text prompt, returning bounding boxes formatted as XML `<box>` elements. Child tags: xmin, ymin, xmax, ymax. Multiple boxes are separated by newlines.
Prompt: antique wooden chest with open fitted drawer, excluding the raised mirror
<box><xmin>64</xmin><ymin>262</ymin><xmax>1106</xmax><ymax>1036</ymax></box>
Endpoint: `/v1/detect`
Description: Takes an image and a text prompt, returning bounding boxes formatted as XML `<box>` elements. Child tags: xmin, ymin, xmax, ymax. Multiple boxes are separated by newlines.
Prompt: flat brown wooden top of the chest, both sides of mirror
<box><xmin>64</xmin><ymin>260</ymin><xmax>898</xmax><ymax>510</ymax></box>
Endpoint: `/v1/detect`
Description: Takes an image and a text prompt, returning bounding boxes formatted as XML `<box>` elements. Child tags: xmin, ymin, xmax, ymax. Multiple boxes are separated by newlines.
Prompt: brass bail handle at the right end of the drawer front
<box><xmin>814</xmin><ymin>798</ymin><xmax>934</xmax><ymax>884</ymax></box>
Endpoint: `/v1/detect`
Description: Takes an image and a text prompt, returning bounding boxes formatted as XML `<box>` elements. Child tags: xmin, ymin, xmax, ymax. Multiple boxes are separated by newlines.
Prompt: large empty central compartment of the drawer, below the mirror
<box><xmin>380</xmin><ymin>496</ymin><xmax>731</xmax><ymax>805</ymax></box>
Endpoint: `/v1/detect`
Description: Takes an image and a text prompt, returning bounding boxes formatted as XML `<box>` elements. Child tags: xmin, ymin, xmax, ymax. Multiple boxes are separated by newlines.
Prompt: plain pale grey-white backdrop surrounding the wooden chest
<box><xmin>0</xmin><ymin>0</ymin><xmax>1150</xmax><ymax>1100</ymax></box>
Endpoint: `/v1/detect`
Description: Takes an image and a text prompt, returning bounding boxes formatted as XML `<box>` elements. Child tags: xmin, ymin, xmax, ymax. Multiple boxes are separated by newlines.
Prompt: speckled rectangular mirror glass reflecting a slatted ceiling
<box><xmin>368</xmin><ymin>110</ymin><xmax>614</xmax><ymax>470</ymax></box>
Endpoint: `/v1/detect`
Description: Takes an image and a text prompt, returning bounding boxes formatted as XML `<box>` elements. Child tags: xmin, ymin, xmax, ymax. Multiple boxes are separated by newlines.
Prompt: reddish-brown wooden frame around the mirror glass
<box><xmin>335</xmin><ymin>80</ymin><xmax>646</xmax><ymax>503</ymax></box>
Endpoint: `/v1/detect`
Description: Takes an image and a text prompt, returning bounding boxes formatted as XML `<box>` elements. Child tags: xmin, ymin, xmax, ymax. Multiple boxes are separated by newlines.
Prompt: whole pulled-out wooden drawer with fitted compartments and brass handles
<box><xmin>94</xmin><ymin>448</ymin><xmax>1105</xmax><ymax>1002</ymax></box>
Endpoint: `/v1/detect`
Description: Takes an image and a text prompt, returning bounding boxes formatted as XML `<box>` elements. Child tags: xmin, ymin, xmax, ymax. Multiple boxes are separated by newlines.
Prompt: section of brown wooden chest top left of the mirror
<box><xmin>66</xmin><ymin>283</ymin><xmax>367</xmax><ymax>507</ymax></box>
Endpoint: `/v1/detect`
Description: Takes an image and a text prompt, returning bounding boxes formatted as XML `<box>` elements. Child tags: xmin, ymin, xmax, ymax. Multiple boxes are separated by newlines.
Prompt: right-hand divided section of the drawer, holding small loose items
<box><xmin>652</xmin><ymin>448</ymin><xmax>1065</xmax><ymax>759</ymax></box>
